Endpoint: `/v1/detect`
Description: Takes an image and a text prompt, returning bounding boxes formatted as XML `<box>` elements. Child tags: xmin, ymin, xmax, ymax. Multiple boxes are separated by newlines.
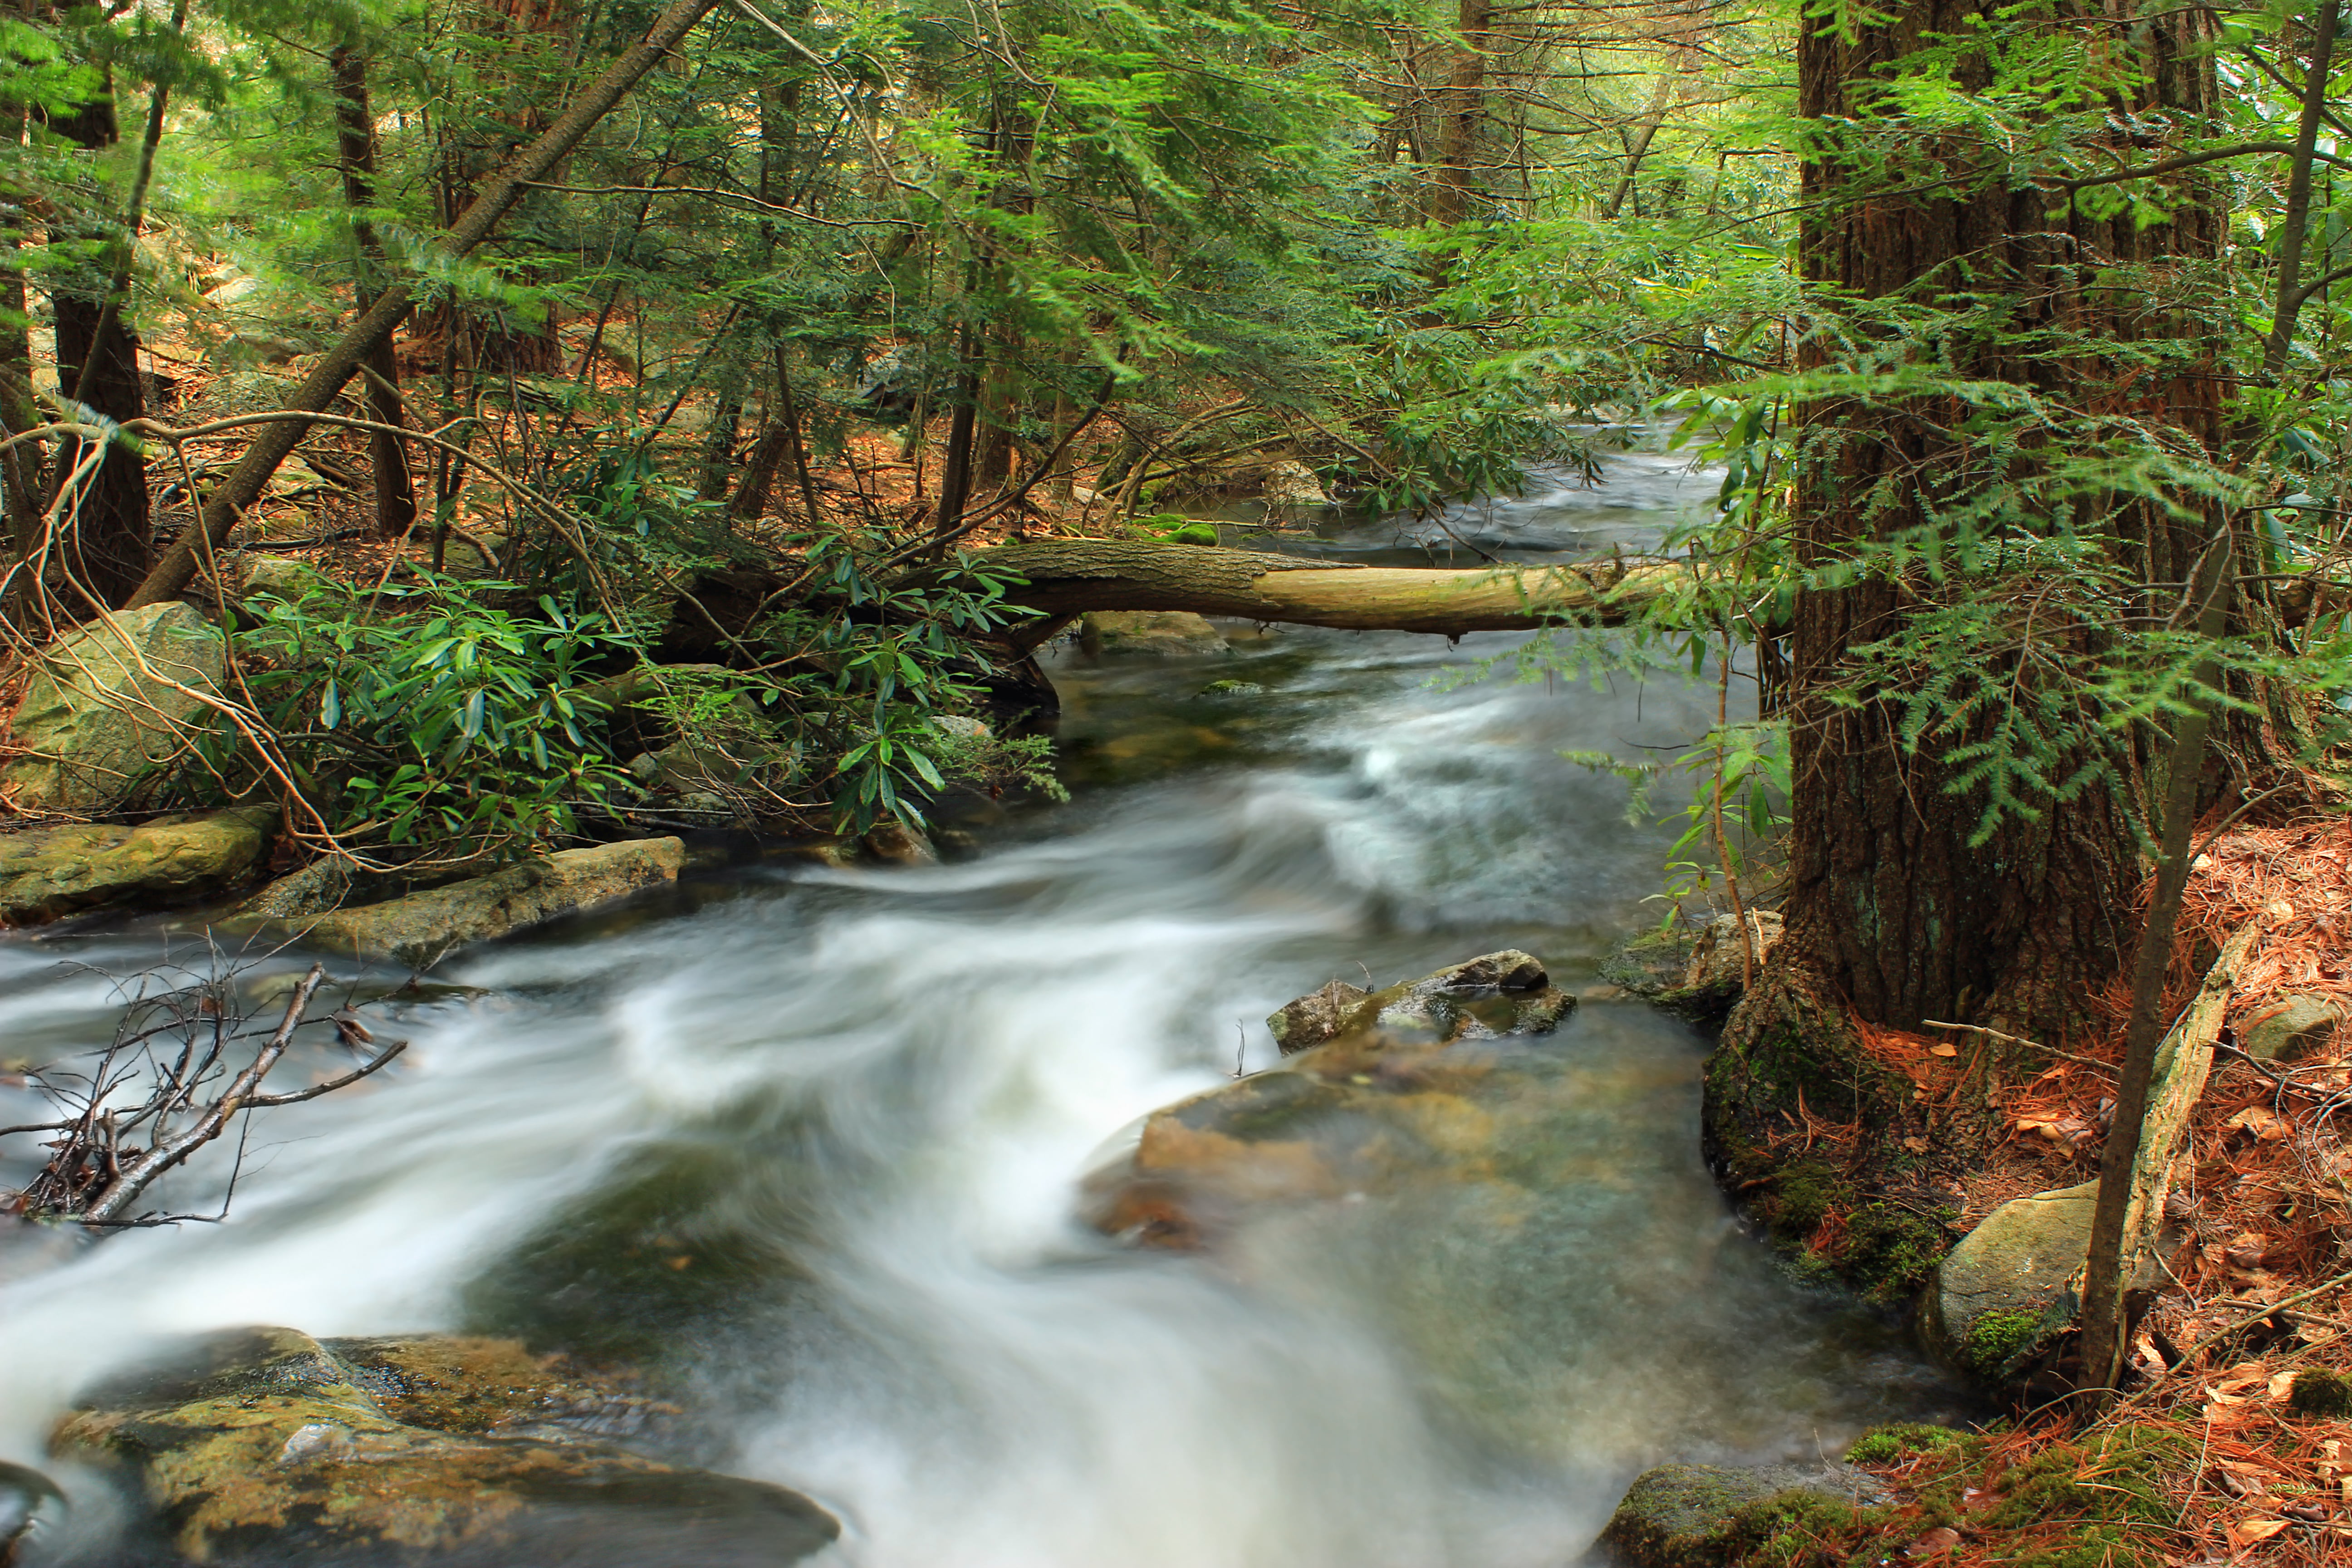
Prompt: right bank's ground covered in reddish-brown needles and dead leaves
<box><xmin>1813</xmin><ymin>816</ymin><xmax>2352</xmax><ymax>1568</ymax></box>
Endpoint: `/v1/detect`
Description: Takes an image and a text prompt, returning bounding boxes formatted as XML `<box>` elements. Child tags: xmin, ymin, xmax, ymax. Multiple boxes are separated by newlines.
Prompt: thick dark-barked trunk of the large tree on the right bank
<box><xmin>1734</xmin><ymin>0</ymin><xmax>2223</xmax><ymax>1053</ymax></box>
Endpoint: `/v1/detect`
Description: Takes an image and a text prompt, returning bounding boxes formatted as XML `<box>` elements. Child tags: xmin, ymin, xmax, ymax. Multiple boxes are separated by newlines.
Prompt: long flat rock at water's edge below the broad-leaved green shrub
<box><xmin>273</xmin><ymin>839</ymin><xmax>687</xmax><ymax>969</ymax></box>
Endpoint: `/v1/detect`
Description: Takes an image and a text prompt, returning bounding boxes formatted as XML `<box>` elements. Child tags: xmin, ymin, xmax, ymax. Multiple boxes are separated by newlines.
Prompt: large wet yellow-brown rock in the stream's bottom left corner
<box><xmin>52</xmin><ymin>1328</ymin><xmax>840</xmax><ymax>1568</ymax></box>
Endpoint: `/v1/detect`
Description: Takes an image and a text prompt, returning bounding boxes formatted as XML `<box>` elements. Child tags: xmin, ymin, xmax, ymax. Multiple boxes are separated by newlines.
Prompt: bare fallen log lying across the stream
<box><xmin>974</xmin><ymin>539</ymin><xmax>1689</xmax><ymax>637</ymax></box>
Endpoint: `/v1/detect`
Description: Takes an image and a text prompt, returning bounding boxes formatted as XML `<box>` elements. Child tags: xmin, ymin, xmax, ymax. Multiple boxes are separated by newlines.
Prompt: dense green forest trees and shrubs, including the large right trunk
<box><xmin>0</xmin><ymin>0</ymin><xmax>2352</xmax><ymax>945</ymax></box>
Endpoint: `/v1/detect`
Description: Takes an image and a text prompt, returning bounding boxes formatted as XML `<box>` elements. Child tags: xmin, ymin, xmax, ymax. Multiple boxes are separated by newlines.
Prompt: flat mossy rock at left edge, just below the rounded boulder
<box><xmin>0</xmin><ymin>806</ymin><xmax>278</xmax><ymax>926</ymax></box>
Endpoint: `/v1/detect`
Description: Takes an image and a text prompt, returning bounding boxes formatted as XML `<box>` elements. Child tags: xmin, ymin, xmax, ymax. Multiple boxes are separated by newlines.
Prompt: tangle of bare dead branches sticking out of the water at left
<box><xmin>0</xmin><ymin>964</ymin><xmax>407</xmax><ymax>1230</ymax></box>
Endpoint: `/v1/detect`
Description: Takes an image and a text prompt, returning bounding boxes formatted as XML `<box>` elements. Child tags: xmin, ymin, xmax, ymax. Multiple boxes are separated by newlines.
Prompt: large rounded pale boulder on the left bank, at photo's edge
<box><xmin>0</xmin><ymin>599</ymin><xmax>228</xmax><ymax>816</ymax></box>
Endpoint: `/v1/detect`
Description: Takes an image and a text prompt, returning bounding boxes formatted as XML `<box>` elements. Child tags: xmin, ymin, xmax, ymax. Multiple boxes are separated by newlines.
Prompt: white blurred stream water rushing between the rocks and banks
<box><xmin>0</xmin><ymin>442</ymin><xmax>1945</xmax><ymax>1568</ymax></box>
